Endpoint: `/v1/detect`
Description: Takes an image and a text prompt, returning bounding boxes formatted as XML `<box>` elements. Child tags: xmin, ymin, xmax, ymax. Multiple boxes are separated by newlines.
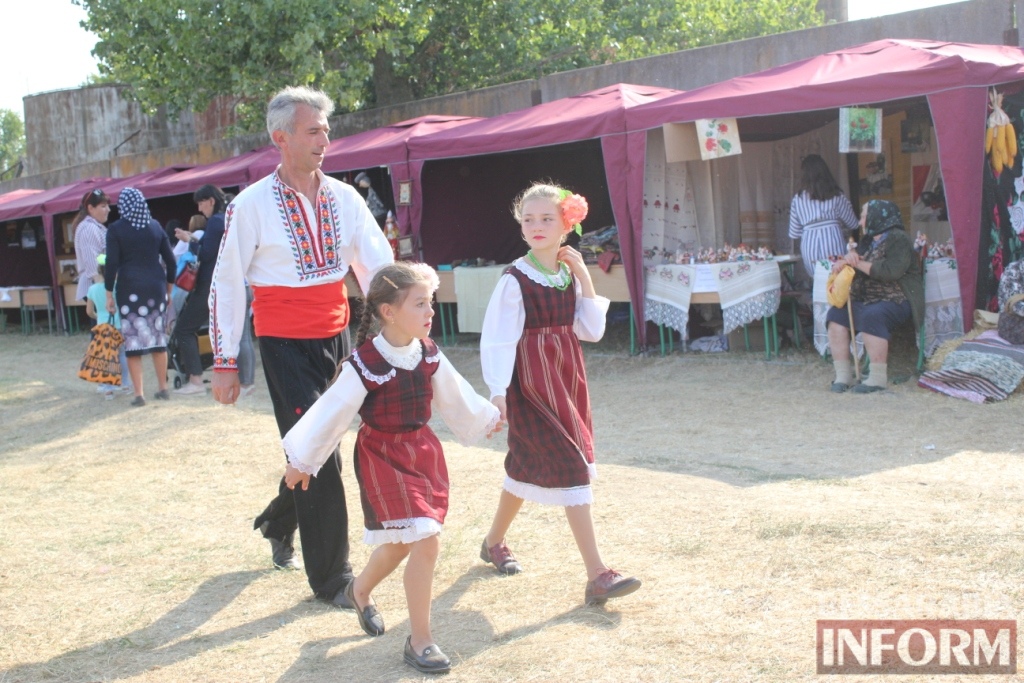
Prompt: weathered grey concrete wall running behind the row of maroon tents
<box><xmin>0</xmin><ymin>0</ymin><xmax>1024</xmax><ymax>194</ymax></box>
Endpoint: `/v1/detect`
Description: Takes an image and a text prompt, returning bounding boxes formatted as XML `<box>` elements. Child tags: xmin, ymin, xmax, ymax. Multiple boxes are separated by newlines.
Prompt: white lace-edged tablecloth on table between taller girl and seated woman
<box><xmin>644</xmin><ymin>261</ymin><xmax>782</xmax><ymax>339</ymax></box>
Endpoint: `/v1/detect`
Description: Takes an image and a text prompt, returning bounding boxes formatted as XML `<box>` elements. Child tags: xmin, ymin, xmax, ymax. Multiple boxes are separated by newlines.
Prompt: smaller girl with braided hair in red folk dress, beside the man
<box><xmin>284</xmin><ymin>262</ymin><xmax>501</xmax><ymax>673</ymax></box>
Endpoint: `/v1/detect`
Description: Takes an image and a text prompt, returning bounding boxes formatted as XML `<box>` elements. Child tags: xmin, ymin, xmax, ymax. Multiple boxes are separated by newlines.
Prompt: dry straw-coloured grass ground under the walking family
<box><xmin>0</xmin><ymin>334</ymin><xmax>1024</xmax><ymax>683</ymax></box>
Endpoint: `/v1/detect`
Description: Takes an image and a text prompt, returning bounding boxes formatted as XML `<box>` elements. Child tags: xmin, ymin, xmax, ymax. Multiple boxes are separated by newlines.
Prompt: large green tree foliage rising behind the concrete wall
<box><xmin>74</xmin><ymin>0</ymin><xmax>823</xmax><ymax>128</ymax></box>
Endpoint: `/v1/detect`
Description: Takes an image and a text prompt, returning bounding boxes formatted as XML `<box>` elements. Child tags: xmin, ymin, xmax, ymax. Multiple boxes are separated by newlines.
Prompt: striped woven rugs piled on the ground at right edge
<box><xmin>918</xmin><ymin>330</ymin><xmax>1024</xmax><ymax>403</ymax></box>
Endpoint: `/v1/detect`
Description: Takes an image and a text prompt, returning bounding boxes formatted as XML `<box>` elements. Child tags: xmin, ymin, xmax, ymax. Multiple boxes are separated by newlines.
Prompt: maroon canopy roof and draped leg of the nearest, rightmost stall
<box><xmin>627</xmin><ymin>40</ymin><xmax>1024</xmax><ymax>333</ymax></box>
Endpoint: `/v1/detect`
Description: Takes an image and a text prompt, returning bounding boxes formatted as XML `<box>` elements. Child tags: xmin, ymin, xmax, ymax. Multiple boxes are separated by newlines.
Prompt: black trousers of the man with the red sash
<box><xmin>254</xmin><ymin>330</ymin><xmax>353</xmax><ymax>599</ymax></box>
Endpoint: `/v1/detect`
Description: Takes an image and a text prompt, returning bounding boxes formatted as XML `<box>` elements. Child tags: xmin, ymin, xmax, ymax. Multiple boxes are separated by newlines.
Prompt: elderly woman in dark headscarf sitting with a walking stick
<box><xmin>825</xmin><ymin>200</ymin><xmax>925</xmax><ymax>393</ymax></box>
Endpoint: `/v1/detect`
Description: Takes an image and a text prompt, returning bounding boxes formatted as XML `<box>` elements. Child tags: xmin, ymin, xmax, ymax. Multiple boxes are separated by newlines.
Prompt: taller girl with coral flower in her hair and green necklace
<box><xmin>480</xmin><ymin>184</ymin><xmax>640</xmax><ymax>604</ymax></box>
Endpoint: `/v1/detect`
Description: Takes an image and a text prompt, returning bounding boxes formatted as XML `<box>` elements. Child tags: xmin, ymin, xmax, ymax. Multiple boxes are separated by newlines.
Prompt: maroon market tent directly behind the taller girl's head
<box><xmin>409</xmin><ymin>83</ymin><xmax>680</xmax><ymax>339</ymax></box>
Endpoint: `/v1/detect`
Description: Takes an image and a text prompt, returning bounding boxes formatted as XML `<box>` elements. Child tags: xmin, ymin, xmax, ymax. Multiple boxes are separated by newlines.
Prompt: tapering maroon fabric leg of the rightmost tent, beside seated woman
<box><xmin>933</xmin><ymin>87</ymin><xmax>988</xmax><ymax>332</ymax></box>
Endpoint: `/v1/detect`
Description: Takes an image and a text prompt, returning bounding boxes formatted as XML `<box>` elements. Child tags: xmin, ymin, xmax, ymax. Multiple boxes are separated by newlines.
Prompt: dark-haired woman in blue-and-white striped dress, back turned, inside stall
<box><xmin>790</xmin><ymin>155</ymin><xmax>858</xmax><ymax>279</ymax></box>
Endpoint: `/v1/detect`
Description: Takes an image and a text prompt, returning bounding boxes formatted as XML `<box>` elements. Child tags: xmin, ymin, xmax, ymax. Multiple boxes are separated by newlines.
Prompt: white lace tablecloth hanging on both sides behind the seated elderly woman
<box><xmin>811</xmin><ymin>258</ymin><xmax>964</xmax><ymax>356</ymax></box>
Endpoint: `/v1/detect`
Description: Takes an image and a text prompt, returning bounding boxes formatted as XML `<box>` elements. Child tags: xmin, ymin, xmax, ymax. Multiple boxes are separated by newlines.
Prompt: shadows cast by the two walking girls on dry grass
<box><xmin>278</xmin><ymin>566</ymin><xmax>621</xmax><ymax>683</ymax></box>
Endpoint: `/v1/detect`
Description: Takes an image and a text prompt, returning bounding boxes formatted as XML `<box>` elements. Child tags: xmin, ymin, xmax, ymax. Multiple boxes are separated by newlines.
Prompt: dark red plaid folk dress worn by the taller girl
<box><xmin>480</xmin><ymin>262</ymin><xmax>607</xmax><ymax>506</ymax></box>
